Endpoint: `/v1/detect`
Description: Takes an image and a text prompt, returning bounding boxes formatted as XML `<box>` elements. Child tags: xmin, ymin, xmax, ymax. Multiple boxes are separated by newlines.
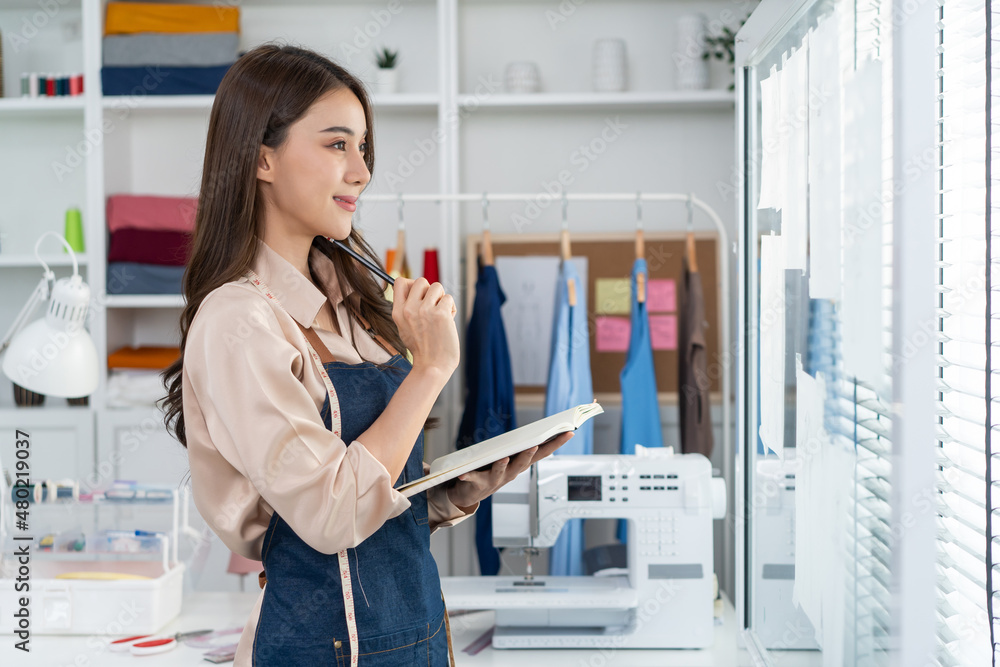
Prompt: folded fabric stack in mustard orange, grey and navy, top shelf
<box><xmin>101</xmin><ymin>2</ymin><xmax>240</xmax><ymax>95</ymax></box>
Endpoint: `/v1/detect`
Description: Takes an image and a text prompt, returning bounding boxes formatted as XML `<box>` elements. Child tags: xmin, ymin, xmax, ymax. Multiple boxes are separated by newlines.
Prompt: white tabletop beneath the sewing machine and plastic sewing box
<box><xmin>0</xmin><ymin>592</ymin><xmax>820</xmax><ymax>667</ymax></box>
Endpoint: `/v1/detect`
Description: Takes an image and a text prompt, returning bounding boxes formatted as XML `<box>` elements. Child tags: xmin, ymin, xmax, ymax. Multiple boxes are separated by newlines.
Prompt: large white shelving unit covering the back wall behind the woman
<box><xmin>0</xmin><ymin>0</ymin><xmax>742</xmax><ymax>574</ymax></box>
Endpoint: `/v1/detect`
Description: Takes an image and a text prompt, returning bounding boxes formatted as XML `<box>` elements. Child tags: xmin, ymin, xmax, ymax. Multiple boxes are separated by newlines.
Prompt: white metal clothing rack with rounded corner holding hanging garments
<box><xmin>359</xmin><ymin>192</ymin><xmax>735</xmax><ymax>488</ymax></box>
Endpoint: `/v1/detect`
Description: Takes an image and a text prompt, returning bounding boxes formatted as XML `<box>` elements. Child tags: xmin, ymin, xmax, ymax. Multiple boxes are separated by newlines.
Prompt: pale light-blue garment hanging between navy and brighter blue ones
<box><xmin>545</xmin><ymin>261</ymin><xmax>594</xmax><ymax>576</ymax></box>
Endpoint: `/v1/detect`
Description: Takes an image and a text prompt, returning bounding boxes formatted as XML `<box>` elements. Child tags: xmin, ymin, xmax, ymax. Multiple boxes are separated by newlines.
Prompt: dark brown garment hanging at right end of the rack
<box><xmin>677</xmin><ymin>257</ymin><xmax>712</xmax><ymax>458</ymax></box>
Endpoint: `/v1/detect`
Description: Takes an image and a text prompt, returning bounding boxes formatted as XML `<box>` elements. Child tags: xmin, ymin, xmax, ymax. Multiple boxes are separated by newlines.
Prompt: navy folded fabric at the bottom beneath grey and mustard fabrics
<box><xmin>101</xmin><ymin>63</ymin><xmax>231</xmax><ymax>96</ymax></box>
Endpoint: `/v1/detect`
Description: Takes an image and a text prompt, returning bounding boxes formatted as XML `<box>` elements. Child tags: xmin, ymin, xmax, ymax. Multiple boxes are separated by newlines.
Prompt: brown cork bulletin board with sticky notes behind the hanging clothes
<box><xmin>465</xmin><ymin>231</ymin><xmax>722</xmax><ymax>400</ymax></box>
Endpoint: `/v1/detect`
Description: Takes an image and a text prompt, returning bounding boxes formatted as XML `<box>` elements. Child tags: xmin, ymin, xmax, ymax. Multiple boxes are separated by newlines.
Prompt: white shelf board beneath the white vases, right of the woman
<box><xmin>457</xmin><ymin>90</ymin><xmax>736</xmax><ymax>111</ymax></box>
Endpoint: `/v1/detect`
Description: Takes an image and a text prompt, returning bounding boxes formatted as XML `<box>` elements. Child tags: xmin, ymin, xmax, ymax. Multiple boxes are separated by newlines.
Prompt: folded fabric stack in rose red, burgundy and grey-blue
<box><xmin>107</xmin><ymin>195</ymin><xmax>198</xmax><ymax>294</ymax></box>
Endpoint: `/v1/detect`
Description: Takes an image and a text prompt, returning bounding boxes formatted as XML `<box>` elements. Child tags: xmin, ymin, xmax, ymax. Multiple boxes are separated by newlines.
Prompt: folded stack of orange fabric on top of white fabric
<box><xmin>108</xmin><ymin>347</ymin><xmax>181</xmax><ymax>408</ymax></box>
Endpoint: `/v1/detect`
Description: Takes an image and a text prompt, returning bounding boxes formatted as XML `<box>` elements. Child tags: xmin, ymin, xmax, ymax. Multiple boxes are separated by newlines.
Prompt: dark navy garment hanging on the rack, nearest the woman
<box><xmin>456</xmin><ymin>266</ymin><xmax>515</xmax><ymax>575</ymax></box>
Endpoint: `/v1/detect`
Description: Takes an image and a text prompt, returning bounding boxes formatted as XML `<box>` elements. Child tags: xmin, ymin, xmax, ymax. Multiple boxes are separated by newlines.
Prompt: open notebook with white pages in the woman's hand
<box><xmin>396</xmin><ymin>403</ymin><xmax>604</xmax><ymax>497</ymax></box>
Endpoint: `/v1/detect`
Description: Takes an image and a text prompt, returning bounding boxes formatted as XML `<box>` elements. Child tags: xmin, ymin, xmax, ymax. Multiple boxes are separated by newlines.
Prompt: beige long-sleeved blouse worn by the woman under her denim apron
<box><xmin>182</xmin><ymin>240</ymin><xmax>470</xmax><ymax>665</ymax></box>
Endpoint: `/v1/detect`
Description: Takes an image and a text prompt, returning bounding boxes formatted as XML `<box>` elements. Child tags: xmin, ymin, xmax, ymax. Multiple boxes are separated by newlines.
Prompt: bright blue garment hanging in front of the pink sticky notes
<box><xmin>618</xmin><ymin>259</ymin><xmax>663</xmax><ymax>543</ymax></box>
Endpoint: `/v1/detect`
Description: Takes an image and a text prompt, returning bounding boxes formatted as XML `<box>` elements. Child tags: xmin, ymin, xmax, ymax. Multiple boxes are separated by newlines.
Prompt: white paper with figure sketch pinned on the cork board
<box><xmin>495</xmin><ymin>256</ymin><xmax>587</xmax><ymax>386</ymax></box>
